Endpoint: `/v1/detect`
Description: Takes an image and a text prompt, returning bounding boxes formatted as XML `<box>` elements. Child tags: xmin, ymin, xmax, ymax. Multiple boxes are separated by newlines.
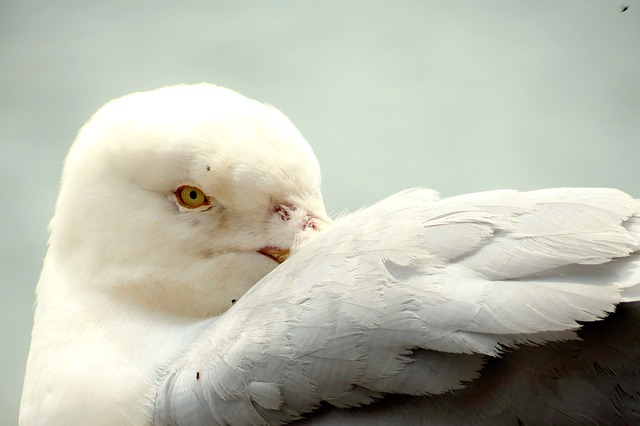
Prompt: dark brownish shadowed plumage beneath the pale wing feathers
<box><xmin>295</xmin><ymin>303</ymin><xmax>640</xmax><ymax>426</ymax></box>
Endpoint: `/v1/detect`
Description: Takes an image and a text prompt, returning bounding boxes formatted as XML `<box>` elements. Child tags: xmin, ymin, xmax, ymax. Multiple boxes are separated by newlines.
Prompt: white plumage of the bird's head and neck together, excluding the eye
<box><xmin>21</xmin><ymin>84</ymin><xmax>328</xmax><ymax>424</ymax></box>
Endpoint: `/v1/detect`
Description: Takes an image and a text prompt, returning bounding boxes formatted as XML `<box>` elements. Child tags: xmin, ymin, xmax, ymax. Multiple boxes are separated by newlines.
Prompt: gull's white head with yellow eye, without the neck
<box><xmin>46</xmin><ymin>84</ymin><xmax>330</xmax><ymax>316</ymax></box>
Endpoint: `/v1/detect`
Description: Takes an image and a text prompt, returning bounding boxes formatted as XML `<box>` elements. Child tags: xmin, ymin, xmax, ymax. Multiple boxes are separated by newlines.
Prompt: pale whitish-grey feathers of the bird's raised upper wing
<box><xmin>155</xmin><ymin>189</ymin><xmax>640</xmax><ymax>425</ymax></box>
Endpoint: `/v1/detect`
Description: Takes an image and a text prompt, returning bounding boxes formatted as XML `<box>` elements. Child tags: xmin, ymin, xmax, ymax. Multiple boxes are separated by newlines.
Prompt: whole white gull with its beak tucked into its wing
<box><xmin>20</xmin><ymin>84</ymin><xmax>640</xmax><ymax>425</ymax></box>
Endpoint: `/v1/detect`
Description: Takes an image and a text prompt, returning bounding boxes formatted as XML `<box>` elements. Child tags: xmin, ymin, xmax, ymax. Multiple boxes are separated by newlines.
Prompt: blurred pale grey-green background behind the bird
<box><xmin>0</xmin><ymin>0</ymin><xmax>640</xmax><ymax>425</ymax></box>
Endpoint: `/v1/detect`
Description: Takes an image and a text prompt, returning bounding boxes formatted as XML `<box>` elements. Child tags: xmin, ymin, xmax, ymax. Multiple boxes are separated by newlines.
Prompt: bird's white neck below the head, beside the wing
<box><xmin>21</xmin><ymin>263</ymin><xmax>210</xmax><ymax>425</ymax></box>
